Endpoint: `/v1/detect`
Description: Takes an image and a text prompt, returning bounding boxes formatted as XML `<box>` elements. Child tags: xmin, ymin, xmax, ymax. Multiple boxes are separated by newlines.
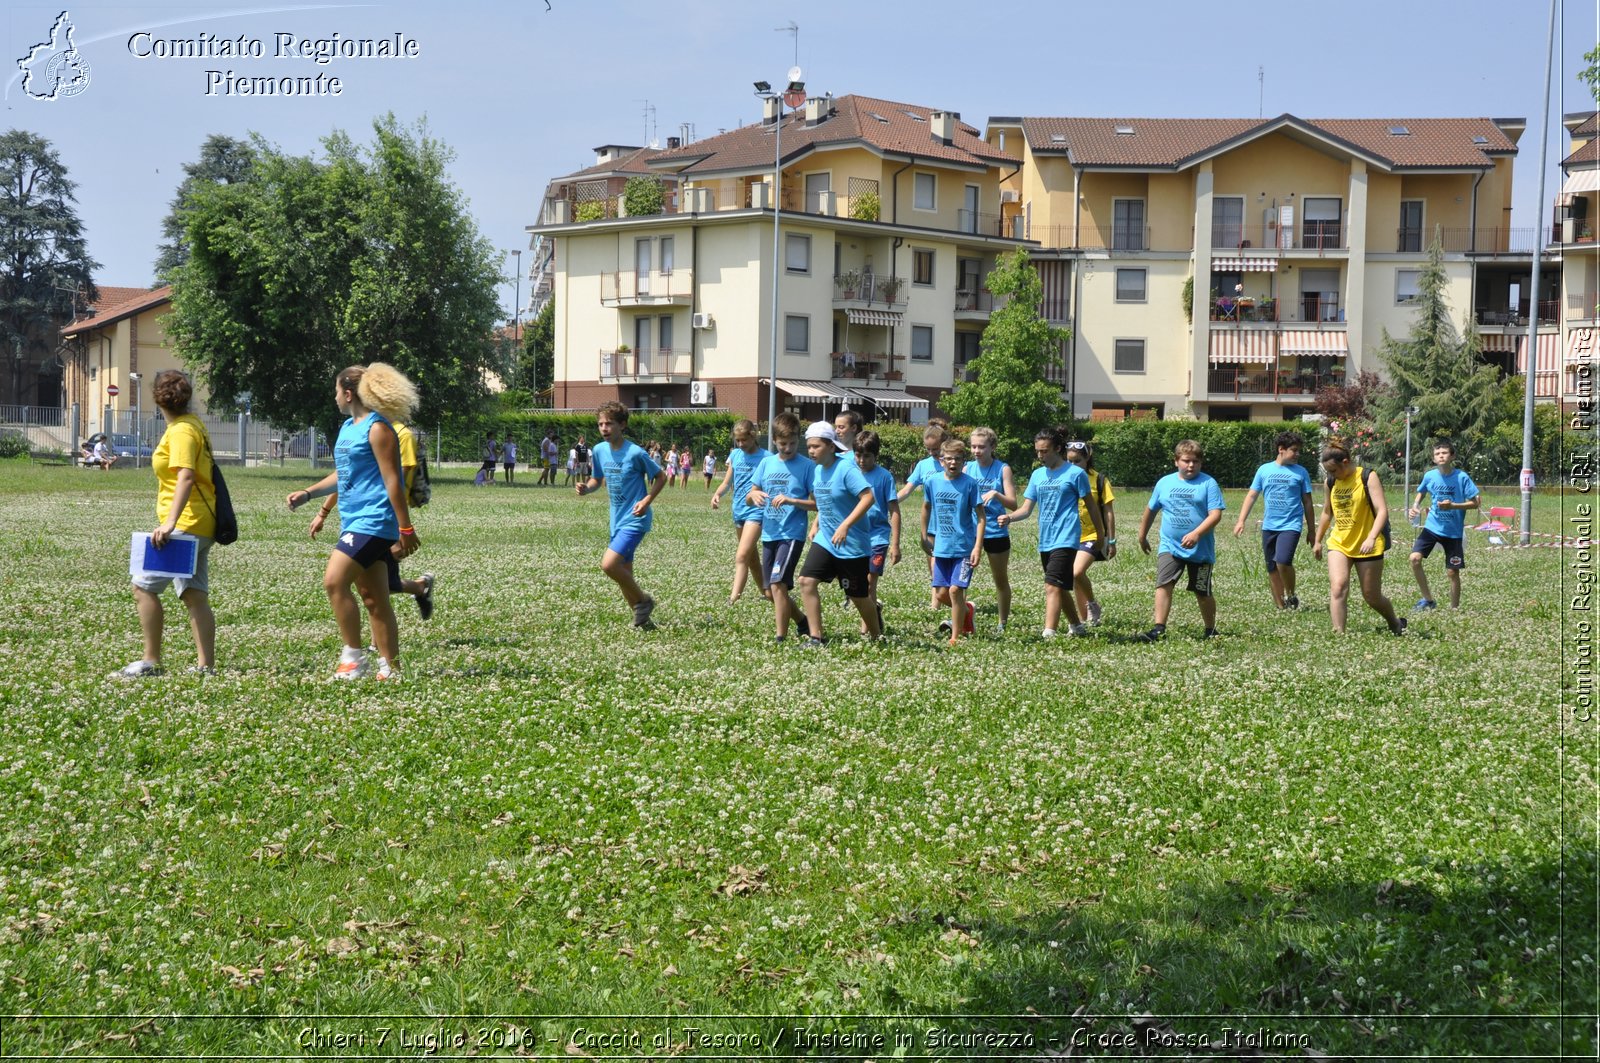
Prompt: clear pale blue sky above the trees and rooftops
<box><xmin>0</xmin><ymin>0</ymin><xmax>1600</xmax><ymax>317</ymax></box>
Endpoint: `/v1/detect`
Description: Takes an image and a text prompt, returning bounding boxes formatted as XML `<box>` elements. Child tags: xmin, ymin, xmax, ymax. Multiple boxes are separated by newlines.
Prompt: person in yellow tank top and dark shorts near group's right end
<box><xmin>1310</xmin><ymin>439</ymin><xmax>1405</xmax><ymax>636</ymax></box>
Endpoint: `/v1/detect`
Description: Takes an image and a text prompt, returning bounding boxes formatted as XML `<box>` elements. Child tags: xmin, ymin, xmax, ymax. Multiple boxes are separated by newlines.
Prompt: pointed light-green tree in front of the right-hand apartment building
<box><xmin>1378</xmin><ymin>234</ymin><xmax>1499</xmax><ymax>445</ymax></box>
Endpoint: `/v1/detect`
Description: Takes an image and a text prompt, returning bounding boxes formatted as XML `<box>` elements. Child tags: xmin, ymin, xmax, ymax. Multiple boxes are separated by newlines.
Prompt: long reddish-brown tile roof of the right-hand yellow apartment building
<box><xmin>1022</xmin><ymin>115</ymin><xmax>1517</xmax><ymax>170</ymax></box>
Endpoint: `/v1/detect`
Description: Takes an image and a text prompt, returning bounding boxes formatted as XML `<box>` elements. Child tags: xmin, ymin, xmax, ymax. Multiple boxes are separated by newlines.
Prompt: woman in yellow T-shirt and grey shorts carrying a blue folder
<box><xmin>115</xmin><ymin>370</ymin><xmax>216</xmax><ymax>679</ymax></box>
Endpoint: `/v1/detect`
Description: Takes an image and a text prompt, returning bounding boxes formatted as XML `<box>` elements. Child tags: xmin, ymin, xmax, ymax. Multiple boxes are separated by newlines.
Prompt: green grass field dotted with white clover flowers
<box><xmin>0</xmin><ymin>463</ymin><xmax>1600</xmax><ymax>1060</ymax></box>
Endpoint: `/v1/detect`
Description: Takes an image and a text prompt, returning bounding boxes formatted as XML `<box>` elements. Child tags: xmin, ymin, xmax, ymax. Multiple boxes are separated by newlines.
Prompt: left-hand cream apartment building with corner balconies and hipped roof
<box><xmin>528</xmin><ymin>96</ymin><xmax>1022</xmax><ymax>419</ymax></box>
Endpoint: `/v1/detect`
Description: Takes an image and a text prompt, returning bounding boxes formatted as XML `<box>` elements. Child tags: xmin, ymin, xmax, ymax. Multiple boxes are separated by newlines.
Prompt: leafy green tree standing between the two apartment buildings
<box><xmin>939</xmin><ymin>248</ymin><xmax>1072</xmax><ymax>453</ymax></box>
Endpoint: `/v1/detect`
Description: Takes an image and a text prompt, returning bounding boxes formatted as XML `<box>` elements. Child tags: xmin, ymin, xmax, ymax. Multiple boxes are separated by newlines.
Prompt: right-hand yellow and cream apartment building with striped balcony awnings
<box><xmin>986</xmin><ymin>115</ymin><xmax>1523</xmax><ymax>419</ymax></box>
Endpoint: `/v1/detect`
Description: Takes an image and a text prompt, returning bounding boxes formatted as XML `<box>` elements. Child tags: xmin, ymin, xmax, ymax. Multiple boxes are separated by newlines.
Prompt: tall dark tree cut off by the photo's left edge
<box><xmin>0</xmin><ymin>130</ymin><xmax>99</xmax><ymax>405</ymax></box>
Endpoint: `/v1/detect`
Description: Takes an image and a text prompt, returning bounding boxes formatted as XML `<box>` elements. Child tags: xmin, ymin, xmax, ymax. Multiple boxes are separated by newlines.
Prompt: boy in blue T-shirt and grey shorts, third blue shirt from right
<box><xmin>1139</xmin><ymin>439</ymin><xmax>1227</xmax><ymax>642</ymax></box>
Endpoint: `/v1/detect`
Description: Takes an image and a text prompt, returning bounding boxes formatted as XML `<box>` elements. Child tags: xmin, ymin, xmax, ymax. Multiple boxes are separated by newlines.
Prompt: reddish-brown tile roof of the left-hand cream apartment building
<box><xmin>651</xmin><ymin>96</ymin><xmax>1016</xmax><ymax>176</ymax></box>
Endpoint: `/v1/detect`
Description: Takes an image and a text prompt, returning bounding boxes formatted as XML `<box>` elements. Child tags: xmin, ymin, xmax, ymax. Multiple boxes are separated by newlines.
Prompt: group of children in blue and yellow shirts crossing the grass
<box><xmin>578</xmin><ymin>402</ymin><xmax>1478</xmax><ymax>647</ymax></box>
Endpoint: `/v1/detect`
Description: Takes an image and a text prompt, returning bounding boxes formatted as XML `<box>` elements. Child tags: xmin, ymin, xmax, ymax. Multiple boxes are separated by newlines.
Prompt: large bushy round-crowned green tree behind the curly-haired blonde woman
<box><xmin>170</xmin><ymin>115</ymin><xmax>502</xmax><ymax>429</ymax></box>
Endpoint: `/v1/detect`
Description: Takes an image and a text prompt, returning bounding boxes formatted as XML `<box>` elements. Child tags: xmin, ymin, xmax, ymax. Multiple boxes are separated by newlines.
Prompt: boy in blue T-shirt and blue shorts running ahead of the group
<box><xmin>578</xmin><ymin>402</ymin><xmax>667</xmax><ymax>629</ymax></box>
